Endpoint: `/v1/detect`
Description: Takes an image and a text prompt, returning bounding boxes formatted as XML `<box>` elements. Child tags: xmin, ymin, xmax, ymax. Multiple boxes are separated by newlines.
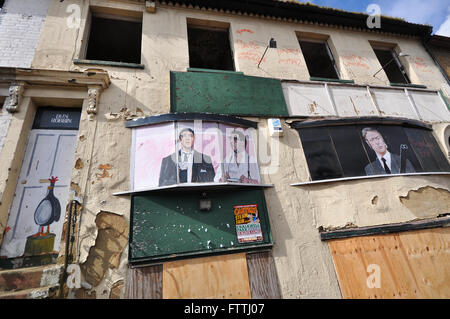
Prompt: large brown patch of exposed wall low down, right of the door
<box><xmin>81</xmin><ymin>211</ymin><xmax>129</xmax><ymax>287</ymax></box>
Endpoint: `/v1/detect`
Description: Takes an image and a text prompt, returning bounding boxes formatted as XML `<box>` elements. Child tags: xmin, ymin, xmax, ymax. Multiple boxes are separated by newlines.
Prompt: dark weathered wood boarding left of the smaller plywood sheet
<box><xmin>125</xmin><ymin>265</ymin><xmax>163</xmax><ymax>299</ymax></box>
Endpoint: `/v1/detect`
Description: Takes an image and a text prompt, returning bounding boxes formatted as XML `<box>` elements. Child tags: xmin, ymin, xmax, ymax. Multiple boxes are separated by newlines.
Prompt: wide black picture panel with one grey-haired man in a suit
<box><xmin>298</xmin><ymin>124</ymin><xmax>450</xmax><ymax>181</ymax></box>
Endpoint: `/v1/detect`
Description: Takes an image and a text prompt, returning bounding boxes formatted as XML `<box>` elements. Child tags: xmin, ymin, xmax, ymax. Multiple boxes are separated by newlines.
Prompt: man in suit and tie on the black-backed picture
<box><xmin>362</xmin><ymin>127</ymin><xmax>415</xmax><ymax>175</ymax></box>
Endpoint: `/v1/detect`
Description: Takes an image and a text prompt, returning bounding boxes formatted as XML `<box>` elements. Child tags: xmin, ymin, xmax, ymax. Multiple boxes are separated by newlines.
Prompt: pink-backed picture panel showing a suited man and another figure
<box><xmin>132</xmin><ymin>120</ymin><xmax>261</xmax><ymax>190</ymax></box>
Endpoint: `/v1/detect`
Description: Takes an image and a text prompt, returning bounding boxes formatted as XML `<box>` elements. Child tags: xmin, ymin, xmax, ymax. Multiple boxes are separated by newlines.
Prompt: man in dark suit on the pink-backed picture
<box><xmin>159</xmin><ymin>128</ymin><xmax>215</xmax><ymax>186</ymax></box>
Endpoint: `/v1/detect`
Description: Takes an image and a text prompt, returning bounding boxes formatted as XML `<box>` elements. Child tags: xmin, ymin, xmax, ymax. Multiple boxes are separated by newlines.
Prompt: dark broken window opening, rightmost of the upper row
<box><xmin>373</xmin><ymin>48</ymin><xmax>411</xmax><ymax>84</ymax></box>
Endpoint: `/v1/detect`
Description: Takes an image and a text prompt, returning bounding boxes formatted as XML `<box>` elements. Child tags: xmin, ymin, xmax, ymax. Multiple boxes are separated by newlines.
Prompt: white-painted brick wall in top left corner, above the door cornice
<box><xmin>0</xmin><ymin>0</ymin><xmax>51</xmax><ymax>68</ymax></box>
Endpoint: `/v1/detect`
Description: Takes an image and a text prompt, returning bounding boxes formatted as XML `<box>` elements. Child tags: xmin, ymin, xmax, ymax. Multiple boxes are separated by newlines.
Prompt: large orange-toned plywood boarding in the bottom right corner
<box><xmin>329</xmin><ymin>228</ymin><xmax>450</xmax><ymax>299</ymax></box>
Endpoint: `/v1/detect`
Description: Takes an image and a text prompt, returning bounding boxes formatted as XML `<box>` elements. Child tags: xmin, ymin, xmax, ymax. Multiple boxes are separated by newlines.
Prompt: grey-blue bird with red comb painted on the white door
<box><xmin>33</xmin><ymin>176</ymin><xmax>61</xmax><ymax>237</ymax></box>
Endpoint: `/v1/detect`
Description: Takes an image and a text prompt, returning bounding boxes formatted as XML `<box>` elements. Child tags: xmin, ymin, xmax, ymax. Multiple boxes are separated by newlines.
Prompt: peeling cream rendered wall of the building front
<box><xmin>28</xmin><ymin>0</ymin><xmax>450</xmax><ymax>298</ymax></box>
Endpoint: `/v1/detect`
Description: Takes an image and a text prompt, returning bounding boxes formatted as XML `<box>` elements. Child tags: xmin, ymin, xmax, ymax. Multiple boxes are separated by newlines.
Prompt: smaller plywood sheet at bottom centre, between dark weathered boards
<box><xmin>163</xmin><ymin>253</ymin><xmax>251</xmax><ymax>299</ymax></box>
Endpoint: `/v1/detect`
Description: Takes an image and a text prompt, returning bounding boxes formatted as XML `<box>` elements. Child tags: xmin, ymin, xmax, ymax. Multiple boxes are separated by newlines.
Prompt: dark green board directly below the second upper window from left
<box><xmin>170</xmin><ymin>71</ymin><xmax>289</xmax><ymax>117</ymax></box>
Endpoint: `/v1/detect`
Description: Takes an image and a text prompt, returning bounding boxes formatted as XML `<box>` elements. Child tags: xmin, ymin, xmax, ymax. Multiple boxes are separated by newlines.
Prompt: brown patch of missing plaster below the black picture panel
<box><xmin>400</xmin><ymin>186</ymin><xmax>450</xmax><ymax>217</ymax></box>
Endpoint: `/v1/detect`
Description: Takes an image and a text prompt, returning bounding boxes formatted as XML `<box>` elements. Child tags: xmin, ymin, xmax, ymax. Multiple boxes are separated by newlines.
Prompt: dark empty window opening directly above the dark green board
<box><xmin>188</xmin><ymin>22</ymin><xmax>234</xmax><ymax>71</ymax></box>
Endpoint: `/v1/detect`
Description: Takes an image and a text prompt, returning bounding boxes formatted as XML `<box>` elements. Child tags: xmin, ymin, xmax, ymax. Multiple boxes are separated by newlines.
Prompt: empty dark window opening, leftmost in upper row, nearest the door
<box><xmin>86</xmin><ymin>16</ymin><xmax>142</xmax><ymax>63</ymax></box>
